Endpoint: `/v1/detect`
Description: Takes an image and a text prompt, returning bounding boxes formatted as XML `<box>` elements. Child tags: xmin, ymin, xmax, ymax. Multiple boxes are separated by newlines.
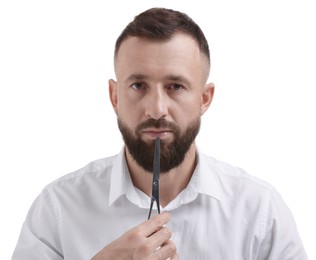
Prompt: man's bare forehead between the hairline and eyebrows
<box><xmin>114</xmin><ymin>33</ymin><xmax>209</xmax><ymax>82</ymax></box>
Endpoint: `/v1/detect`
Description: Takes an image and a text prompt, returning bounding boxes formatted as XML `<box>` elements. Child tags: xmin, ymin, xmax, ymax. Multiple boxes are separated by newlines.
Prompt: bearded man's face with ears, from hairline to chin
<box><xmin>110</xmin><ymin>34</ymin><xmax>213</xmax><ymax>172</ymax></box>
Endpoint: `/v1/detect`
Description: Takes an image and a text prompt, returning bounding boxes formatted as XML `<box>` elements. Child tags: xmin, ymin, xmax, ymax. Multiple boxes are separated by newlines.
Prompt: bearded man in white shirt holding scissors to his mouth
<box><xmin>13</xmin><ymin>8</ymin><xmax>307</xmax><ymax>260</ymax></box>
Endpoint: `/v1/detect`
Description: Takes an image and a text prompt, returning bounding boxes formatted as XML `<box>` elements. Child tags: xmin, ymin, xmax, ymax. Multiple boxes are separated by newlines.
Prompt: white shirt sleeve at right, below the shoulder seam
<box><xmin>258</xmin><ymin>190</ymin><xmax>308</xmax><ymax>260</ymax></box>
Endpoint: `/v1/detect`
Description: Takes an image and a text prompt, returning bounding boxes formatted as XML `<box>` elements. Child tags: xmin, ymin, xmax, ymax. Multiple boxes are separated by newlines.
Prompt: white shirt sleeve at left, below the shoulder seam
<box><xmin>12</xmin><ymin>189</ymin><xmax>64</xmax><ymax>260</ymax></box>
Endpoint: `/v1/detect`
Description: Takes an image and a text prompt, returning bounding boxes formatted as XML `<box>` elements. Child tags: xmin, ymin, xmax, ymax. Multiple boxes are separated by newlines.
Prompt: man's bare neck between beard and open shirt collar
<box><xmin>125</xmin><ymin>143</ymin><xmax>196</xmax><ymax>207</ymax></box>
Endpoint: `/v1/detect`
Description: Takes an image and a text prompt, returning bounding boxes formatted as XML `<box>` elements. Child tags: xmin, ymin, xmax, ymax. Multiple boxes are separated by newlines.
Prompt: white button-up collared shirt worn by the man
<box><xmin>12</xmin><ymin>150</ymin><xmax>307</xmax><ymax>260</ymax></box>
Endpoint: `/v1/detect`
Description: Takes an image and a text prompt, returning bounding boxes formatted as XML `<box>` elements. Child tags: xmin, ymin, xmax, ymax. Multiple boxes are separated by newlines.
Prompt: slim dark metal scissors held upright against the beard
<box><xmin>148</xmin><ymin>137</ymin><xmax>160</xmax><ymax>219</ymax></box>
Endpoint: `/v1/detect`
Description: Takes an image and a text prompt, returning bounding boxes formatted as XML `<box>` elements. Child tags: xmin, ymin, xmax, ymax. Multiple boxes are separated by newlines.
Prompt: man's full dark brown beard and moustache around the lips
<box><xmin>117</xmin><ymin>117</ymin><xmax>201</xmax><ymax>173</ymax></box>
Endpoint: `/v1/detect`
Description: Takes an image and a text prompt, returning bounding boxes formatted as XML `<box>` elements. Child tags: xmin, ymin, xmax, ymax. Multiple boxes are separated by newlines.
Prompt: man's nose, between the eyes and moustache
<box><xmin>145</xmin><ymin>87</ymin><xmax>168</xmax><ymax>120</ymax></box>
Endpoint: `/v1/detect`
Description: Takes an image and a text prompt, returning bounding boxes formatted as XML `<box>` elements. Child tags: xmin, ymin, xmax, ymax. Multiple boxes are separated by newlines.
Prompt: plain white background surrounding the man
<box><xmin>0</xmin><ymin>0</ymin><xmax>316</xmax><ymax>259</ymax></box>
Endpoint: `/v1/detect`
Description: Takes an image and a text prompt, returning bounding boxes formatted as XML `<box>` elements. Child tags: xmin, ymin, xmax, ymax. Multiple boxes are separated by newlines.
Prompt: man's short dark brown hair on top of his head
<box><xmin>115</xmin><ymin>8</ymin><xmax>210</xmax><ymax>65</ymax></box>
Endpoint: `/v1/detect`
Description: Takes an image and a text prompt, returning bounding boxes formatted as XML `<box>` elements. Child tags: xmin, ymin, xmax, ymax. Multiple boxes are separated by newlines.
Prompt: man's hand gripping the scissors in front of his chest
<box><xmin>92</xmin><ymin>212</ymin><xmax>178</xmax><ymax>260</ymax></box>
